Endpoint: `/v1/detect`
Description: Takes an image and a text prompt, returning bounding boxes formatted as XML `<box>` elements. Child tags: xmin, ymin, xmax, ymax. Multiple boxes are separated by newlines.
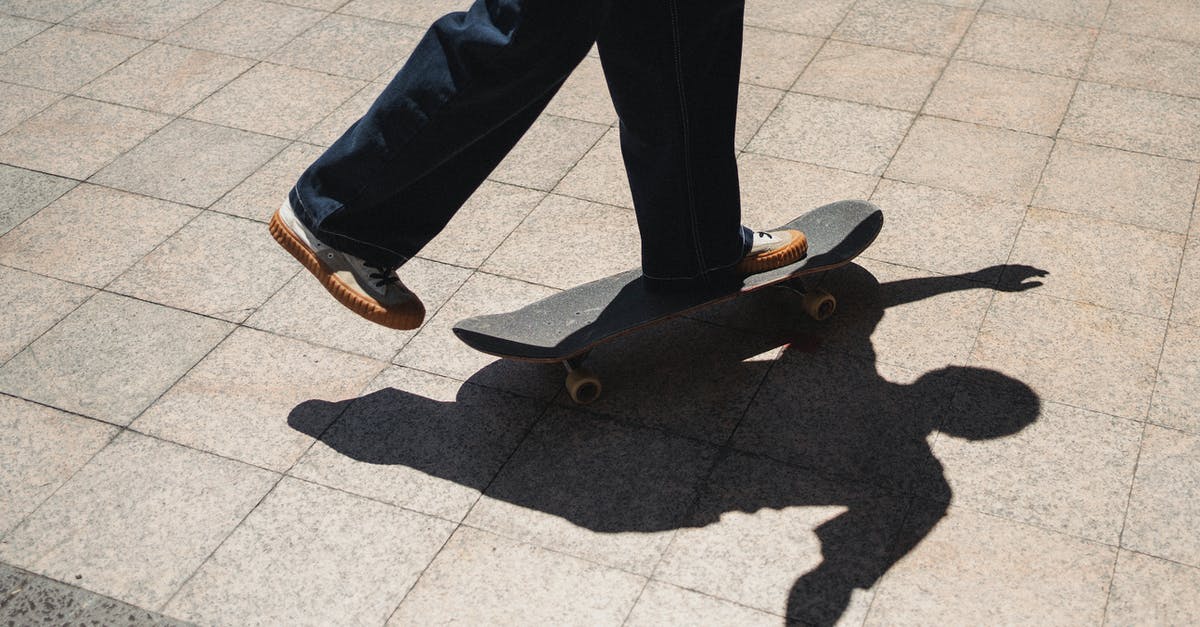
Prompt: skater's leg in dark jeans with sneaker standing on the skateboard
<box><xmin>599</xmin><ymin>0</ymin><xmax>806</xmax><ymax>288</ymax></box>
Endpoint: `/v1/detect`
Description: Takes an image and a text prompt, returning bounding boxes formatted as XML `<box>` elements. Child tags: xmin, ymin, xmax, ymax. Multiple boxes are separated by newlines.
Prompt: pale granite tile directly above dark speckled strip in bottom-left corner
<box><xmin>0</xmin><ymin>432</ymin><xmax>276</xmax><ymax>607</ymax></box>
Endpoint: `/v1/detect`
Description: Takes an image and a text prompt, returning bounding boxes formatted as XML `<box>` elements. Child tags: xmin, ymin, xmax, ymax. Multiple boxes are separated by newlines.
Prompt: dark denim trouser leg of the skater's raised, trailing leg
<box><xmin>290</xmin><ymin>0</ymin><xmax>607</xmax><ymax>264</ymax></box>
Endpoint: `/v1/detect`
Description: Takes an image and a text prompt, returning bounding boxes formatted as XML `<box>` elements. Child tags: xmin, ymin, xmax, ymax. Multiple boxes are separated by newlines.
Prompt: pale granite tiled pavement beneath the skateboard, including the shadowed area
<box><xmin>0</xmin><ymin>0</ymin><xmax>1200</xmax><ymax>626</ymax></box>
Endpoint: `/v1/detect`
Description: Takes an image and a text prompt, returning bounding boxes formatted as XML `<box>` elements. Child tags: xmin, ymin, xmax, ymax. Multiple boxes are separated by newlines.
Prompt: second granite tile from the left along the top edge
<box><xmin>64</xmin><ymin>0</ymin><xmax>221</xmax><ymax>40</ymax></box>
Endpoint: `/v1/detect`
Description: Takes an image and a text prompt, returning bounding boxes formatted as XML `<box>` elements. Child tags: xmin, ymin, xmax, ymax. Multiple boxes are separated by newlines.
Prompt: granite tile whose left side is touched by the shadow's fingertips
<box><xmin>1010</xmin><ymin>208</ymin><xmax>1184</xmax><ymax>318</ymax></box>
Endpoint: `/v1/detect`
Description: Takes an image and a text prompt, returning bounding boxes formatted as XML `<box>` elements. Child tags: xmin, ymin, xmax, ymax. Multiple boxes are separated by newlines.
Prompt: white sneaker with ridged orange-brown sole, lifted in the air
<box><xmin>271</xmin><ymin>201</ymin><xmax>425</xmax><ymax>329</ymax></box>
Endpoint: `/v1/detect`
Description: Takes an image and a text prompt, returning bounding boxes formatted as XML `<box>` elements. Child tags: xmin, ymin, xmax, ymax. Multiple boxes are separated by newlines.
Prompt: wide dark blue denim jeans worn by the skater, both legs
<box><xmin>290</xmin><ymin>0</ymin><xmax>748</xmax><ymax>286</ymax></box>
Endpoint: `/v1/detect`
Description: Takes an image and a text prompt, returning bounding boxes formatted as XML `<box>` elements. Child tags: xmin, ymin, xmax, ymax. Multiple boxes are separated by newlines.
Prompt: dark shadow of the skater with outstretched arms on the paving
<box><xmin>288</xmin><ymin>264</ymin><xmax>1045</xmax><ymax>625</ymax></box>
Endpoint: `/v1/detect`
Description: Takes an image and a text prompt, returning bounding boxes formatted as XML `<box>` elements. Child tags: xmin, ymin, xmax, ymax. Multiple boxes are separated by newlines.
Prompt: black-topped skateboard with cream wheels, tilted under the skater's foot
<box><xmin>454</xmin><ymin>201</ymin><xmax>883</xmax><ymax>405</ymax></box>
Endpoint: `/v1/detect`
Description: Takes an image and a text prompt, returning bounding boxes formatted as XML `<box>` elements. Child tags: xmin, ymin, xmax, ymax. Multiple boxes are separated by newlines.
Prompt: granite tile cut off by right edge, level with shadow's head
<box><xmin>1148</xmin><ymin>324</ymin><xmax>1200</xmax><ymax>435</ymax></box>
